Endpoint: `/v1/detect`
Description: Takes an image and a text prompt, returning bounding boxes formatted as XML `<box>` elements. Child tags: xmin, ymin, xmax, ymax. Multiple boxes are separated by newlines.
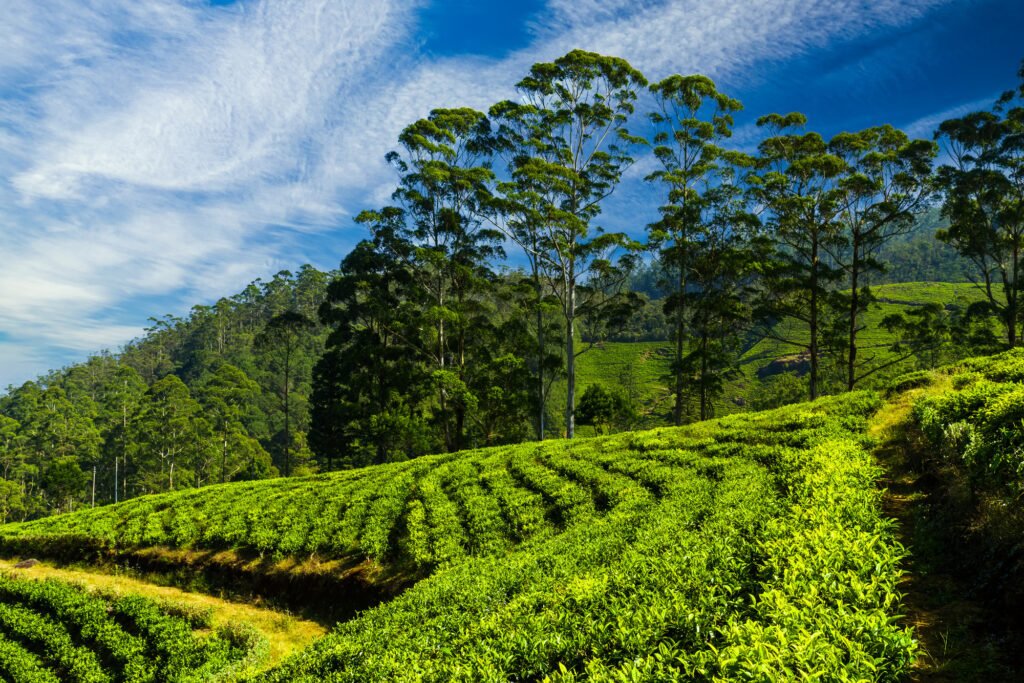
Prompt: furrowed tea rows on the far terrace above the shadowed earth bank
<box><xmin>0</xmin><ymin>435</ymin><xmax>737</xmax><ymax>569</ymax></box>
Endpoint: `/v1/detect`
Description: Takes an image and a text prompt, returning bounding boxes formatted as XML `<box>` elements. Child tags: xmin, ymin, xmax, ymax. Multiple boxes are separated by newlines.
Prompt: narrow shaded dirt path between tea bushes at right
<box><xmin>870</xmin><ymin>392</ymin><xmax>1024</xmax><ymax>683</ymax></box>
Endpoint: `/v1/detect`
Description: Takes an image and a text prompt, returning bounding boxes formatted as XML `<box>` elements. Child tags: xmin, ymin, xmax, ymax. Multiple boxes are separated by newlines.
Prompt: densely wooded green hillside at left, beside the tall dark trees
<box><xmin>0</xmin><ymin>266</ymin><xmax>329</xmax><ymax>519</ymax></box>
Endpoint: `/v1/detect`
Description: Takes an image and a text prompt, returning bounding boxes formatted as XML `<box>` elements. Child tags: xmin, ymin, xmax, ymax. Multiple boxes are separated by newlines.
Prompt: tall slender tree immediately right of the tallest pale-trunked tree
<box><xmin>647</xmin><ymin>75</ymin><xmax>742</xmax><ymax>425</ymax></box>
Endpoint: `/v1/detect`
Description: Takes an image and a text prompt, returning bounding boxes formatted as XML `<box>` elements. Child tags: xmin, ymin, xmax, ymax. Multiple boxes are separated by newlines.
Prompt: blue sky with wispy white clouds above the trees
<box><xmin>0</xmin><ymin>0</ymin><xmax>1024</xmax><ymax>387</ymax></box>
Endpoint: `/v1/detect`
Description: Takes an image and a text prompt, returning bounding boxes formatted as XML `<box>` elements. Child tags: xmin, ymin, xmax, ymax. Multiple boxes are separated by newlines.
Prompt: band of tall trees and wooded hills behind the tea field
<box><xmin>0</xmin><ymin>50</ymin><xmax>1024</xmax><ymax>528</ymax></box>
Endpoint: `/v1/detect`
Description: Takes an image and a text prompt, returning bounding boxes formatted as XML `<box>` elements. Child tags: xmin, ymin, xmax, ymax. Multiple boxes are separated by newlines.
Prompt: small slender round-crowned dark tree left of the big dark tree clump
<box><xmin>254</xmin><ymin>310</ymin><xmax>314</xmax><ymax>476</ymax></box>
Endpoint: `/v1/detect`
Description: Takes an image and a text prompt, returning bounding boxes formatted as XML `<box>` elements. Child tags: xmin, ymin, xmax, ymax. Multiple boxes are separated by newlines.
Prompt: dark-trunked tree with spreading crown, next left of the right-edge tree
<box><xmin>828</xmin><ymin>125</ymin><xmax>937</xmax><ymax>391</ymax></box>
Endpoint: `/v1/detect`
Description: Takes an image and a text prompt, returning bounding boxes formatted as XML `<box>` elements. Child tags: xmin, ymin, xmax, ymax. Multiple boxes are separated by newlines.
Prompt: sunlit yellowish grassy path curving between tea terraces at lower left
<box><xmin>0</xmin><ymin>559</ymin><xmax>327</xmax><ymax>667</ymax></box>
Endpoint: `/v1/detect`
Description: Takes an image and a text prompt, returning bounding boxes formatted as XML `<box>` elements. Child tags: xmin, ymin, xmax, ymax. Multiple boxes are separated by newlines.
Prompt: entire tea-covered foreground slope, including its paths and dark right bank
<box><xmin>6</xmin><ymin>350</ymin><xmax>1024</xmax><ymax>683</ymax></box>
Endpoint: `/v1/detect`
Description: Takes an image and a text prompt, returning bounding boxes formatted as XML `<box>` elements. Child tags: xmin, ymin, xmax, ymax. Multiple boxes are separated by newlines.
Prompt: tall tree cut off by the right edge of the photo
<box><xmin>935</xmin><ymin>66</ymin><xmax>1024</xmax><ymax>347</ymax></box>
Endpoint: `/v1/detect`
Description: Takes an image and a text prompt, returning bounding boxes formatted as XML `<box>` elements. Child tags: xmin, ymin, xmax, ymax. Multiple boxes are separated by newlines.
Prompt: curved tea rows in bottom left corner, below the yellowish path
<box><xmin>0</xmin><ymin>574</ymin><xmax>267</xmax><ymax>683</ymax></box>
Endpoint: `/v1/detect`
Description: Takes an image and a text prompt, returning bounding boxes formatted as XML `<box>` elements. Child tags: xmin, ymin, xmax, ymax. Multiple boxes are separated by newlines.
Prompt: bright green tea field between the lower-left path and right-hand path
<box><xmin>0</xmin><ymin>393</ymin><xmax>914</xmax><ymax>681</ymax></box>
